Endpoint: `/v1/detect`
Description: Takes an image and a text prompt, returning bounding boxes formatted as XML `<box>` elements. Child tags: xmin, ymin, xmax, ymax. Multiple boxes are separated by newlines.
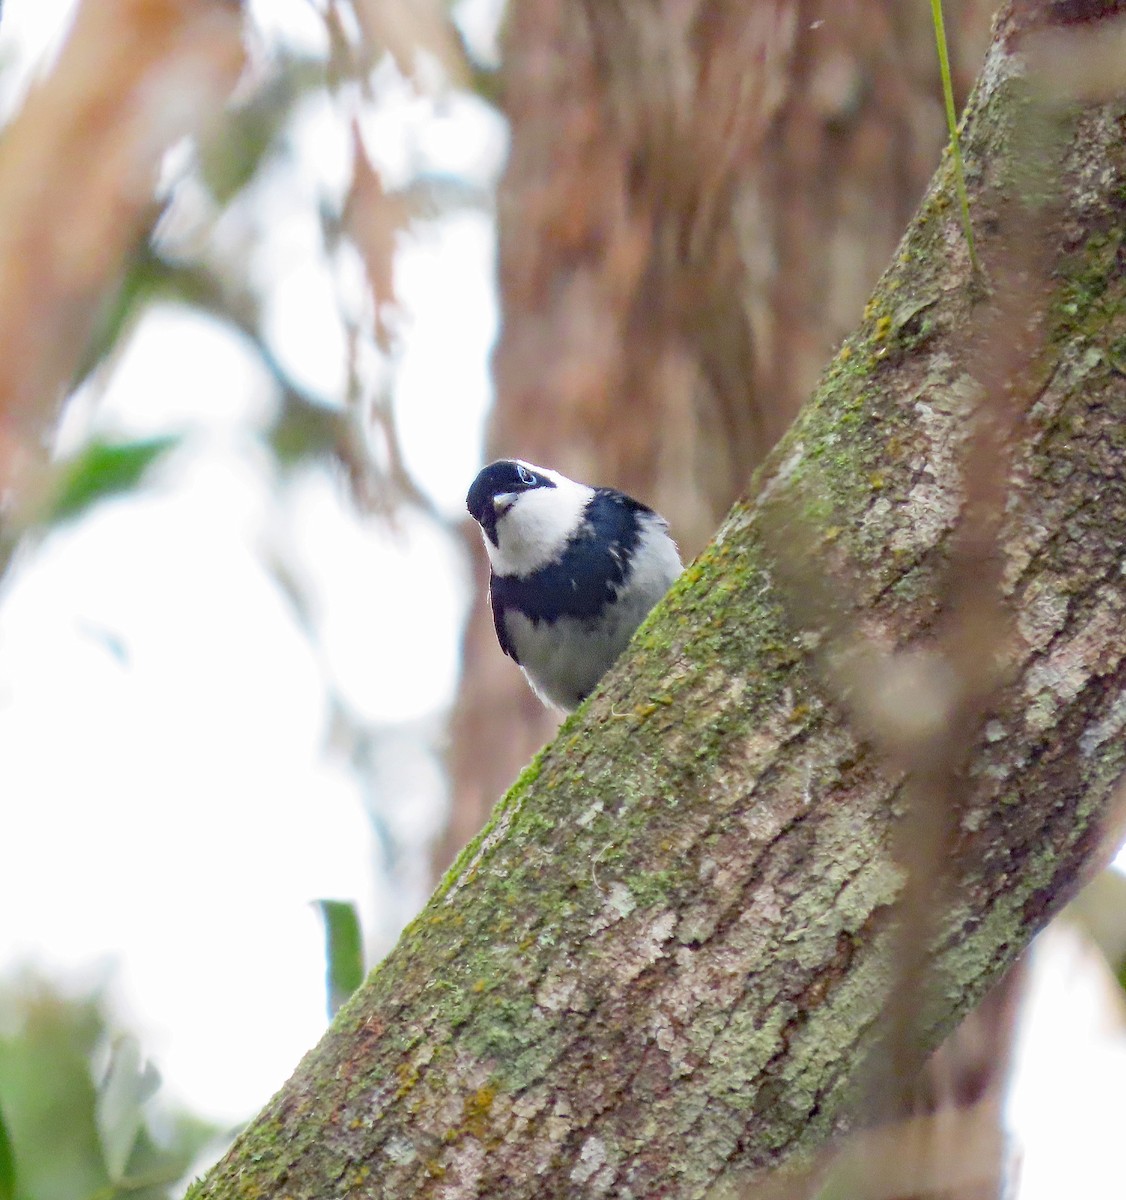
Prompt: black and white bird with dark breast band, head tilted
<box><xmin>466</xmin><ymin>458</ymin><xmax>681</xmax><ymax>710</ymax></box>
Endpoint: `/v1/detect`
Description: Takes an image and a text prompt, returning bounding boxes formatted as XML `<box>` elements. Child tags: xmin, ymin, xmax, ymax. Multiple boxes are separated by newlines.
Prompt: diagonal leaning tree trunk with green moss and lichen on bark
<box><xmin>192</xmin><ymin>5</ymin><xmax>1126</xmax><ymax>1200</ymax></box>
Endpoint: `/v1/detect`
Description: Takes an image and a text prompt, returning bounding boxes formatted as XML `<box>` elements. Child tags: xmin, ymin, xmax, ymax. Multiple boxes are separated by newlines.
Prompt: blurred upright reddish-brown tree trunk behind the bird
<box><xmin>436</xmin><ymin>0</ymin><xmax>995</xmax><ymax>870</ymax></box>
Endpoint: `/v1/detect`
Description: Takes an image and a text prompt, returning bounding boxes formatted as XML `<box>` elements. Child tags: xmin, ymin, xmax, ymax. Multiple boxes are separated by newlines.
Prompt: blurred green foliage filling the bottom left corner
<box><xmin>0</xmin><ymin>980</ymin><xmax>220</xmax><ymax>1200</ymax></box>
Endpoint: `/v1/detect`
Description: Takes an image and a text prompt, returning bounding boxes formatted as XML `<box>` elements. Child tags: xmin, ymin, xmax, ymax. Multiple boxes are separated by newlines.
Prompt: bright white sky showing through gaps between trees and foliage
<box><xmin>0</xmin><ymin>0</ymin><xmax>1126</xmax><ymax>1200</ymax></box>
